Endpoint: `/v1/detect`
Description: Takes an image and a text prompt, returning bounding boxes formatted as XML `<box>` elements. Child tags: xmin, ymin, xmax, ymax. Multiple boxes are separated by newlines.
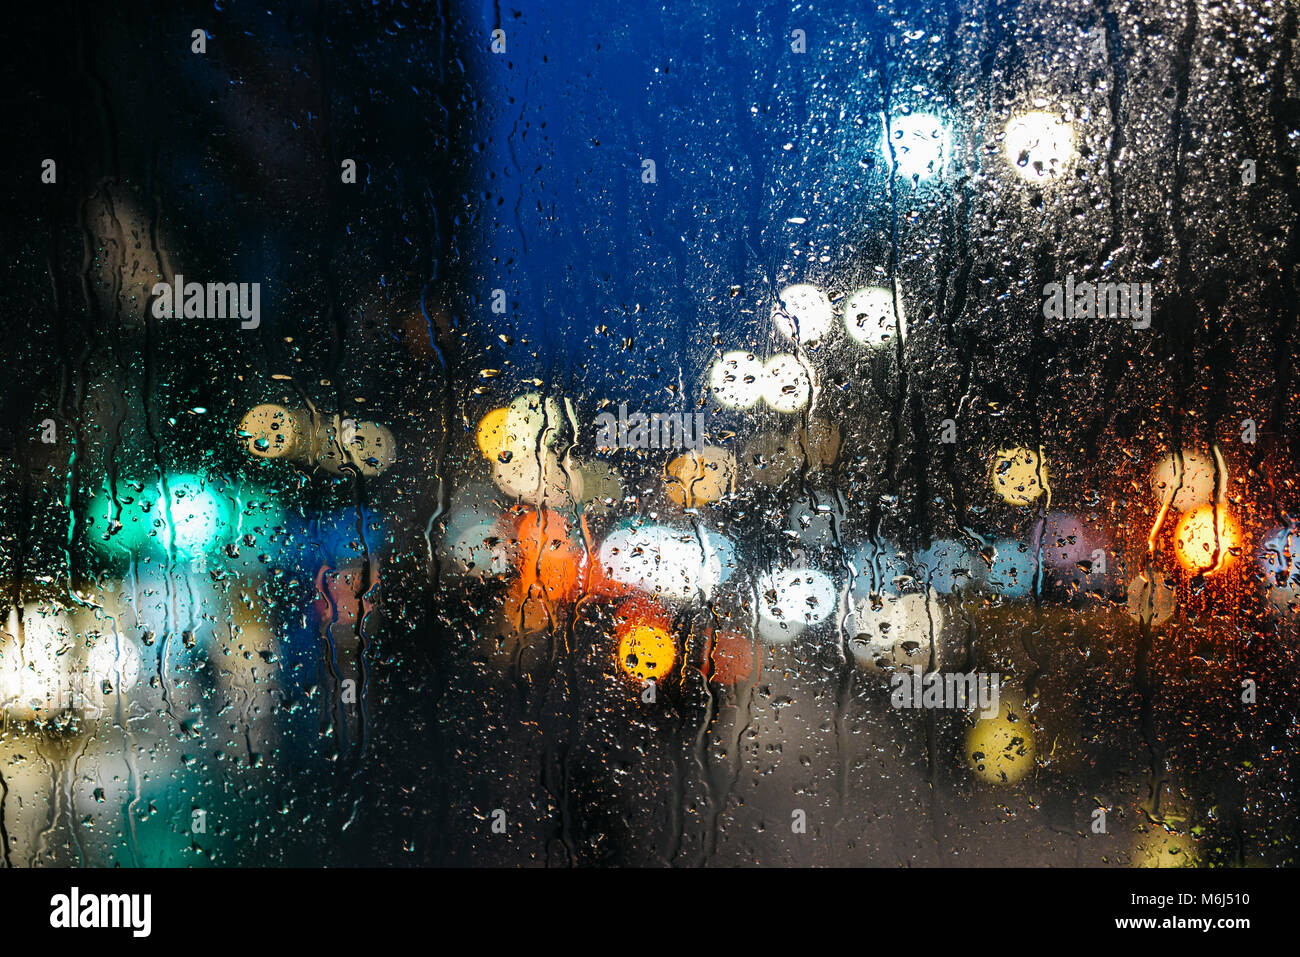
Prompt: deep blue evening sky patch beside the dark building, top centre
<box><xmin>462</xmin><ymin>3</ymin><xmax>932</xmax><ymax>395</ymax></box>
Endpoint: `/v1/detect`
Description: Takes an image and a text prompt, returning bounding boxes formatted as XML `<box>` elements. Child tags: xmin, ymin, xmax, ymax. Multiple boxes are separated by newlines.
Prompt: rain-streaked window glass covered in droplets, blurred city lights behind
<box><xmin>0</xmin><ymin>0</ymin><xmax>1300</xmax><ymax>867</ymax></box>
